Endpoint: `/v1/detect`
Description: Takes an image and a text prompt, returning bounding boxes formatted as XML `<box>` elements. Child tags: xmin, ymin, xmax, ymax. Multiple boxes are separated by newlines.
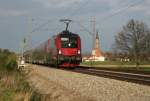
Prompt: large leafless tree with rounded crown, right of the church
<box><xmin>115</xmin><ymin>19</ymin><xmax>150</xmax><ymax>65</ymax></box>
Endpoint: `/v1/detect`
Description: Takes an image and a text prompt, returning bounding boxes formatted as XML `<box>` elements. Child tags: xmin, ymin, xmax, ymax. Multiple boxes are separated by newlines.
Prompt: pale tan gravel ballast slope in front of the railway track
<box><xmin>28</xmin><ymin>65</ymin><xmax>150</xmax><ymax>101</ymax></box>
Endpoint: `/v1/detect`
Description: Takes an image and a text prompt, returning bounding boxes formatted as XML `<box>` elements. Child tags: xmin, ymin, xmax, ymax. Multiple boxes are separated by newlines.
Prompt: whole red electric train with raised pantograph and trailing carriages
<box><xmin>26</xmin><ymin>20</ymin><xmax>82</xmax><ymax>67</ymax></box>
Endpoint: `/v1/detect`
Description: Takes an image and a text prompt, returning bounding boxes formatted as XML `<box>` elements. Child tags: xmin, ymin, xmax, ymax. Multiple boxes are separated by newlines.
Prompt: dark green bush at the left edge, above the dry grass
<box><xmin>0</xmin><ymin>48</ymin><xmax>17</xmax><ymax>71</ymax></box>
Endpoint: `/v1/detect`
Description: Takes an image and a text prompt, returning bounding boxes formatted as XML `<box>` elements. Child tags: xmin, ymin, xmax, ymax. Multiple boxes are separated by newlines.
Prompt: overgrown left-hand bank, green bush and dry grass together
<box><xmin>0</xmin><ymin>49</ymin><xmax>42</xmax><ymax>101</ymax></box>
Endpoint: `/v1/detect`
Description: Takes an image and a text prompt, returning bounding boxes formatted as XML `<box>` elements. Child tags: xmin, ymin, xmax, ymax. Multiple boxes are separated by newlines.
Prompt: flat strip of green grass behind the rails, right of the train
<box><xmin>81</xmin><ymin>61</ymin><xmax>150</xmax><ymax>72</ymax></box>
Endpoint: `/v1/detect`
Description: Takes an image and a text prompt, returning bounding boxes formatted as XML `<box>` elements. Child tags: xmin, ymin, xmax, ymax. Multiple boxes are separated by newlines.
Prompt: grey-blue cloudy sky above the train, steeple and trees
<box><xmin>0</xmin><ymin>0</ymin><xmax>150</xmax><ymax>52</ymax></box>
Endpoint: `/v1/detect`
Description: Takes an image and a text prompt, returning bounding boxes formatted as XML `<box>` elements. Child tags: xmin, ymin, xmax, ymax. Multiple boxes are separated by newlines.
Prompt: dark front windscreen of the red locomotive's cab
<box><xmin>61</xmin><ymin>37</ymin><xmax>77</xmax><ymax>48</ymax></box>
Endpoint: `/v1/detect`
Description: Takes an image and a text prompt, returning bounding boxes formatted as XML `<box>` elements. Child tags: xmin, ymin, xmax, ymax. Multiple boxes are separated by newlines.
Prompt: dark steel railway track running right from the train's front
<box><xmin>65</xmin><ymin>67</ymin><xmax>150</xmax><ymax>86</ymax></box>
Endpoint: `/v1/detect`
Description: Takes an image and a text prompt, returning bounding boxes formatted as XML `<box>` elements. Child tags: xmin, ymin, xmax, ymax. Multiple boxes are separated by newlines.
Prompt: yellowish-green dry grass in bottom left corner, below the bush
<box><xmin>0</xmin><ymin>71</ymin><xmax>47</xmax><ymax>101</ymax></box>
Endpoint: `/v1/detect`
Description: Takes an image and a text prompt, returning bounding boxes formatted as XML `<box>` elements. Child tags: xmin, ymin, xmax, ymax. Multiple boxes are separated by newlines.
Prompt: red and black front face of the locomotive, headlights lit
<box><xmin>56</xmin><ymin>31</ymin><xmax>82</xmax><ymax>67</ymax></box>
